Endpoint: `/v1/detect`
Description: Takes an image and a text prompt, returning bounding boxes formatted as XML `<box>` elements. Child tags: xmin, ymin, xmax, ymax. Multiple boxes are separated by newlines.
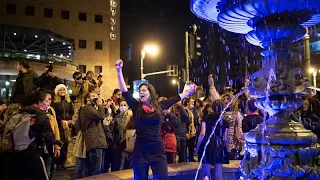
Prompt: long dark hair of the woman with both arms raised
<box><xmin>137</xmin><ymin>83</ymin><xmax>162</xmax><ymax>119</ymax></box>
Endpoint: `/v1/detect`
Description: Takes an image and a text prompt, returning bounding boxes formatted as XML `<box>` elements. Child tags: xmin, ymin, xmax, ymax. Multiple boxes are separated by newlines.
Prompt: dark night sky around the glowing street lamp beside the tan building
<box><xmin>120</xmin><ymin>0</ymin><xmax>196</xmax><ymax>96</ymax></box>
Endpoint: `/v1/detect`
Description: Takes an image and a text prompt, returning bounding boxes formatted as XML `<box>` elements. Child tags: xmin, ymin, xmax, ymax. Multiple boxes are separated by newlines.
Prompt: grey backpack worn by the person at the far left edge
<box><xmin>0</xmin><ymin>113</ymin><xmax>35</xmax><ymax>152</ymax></box>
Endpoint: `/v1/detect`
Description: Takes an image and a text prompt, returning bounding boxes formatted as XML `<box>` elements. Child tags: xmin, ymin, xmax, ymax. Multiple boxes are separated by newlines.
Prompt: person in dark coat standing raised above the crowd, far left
<box><xmin>11</xmin><ymin>60</ymin><xmax>39</xmax><ymax>106</ymax></box>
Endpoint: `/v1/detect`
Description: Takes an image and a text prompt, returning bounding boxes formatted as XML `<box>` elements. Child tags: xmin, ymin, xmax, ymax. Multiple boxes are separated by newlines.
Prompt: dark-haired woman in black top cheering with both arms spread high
<box><xmin>115</xmin><ymin>59</ymin><xmax>196</xmax><ymax>180</ymax></box>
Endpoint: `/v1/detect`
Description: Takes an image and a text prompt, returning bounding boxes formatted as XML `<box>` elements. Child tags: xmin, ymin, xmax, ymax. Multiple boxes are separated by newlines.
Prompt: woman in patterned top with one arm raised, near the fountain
<box><xmin>208</xmin><ymin>74</ymin><xmax>243</xmax><ymax>160</ymax></box>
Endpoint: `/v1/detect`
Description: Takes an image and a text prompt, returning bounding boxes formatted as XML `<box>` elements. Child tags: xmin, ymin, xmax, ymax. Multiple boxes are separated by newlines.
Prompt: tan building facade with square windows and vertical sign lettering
<box><xmin>0</xmin><ymin>0</ymin><xmax>120</xmax><ymax>97</ymax></box>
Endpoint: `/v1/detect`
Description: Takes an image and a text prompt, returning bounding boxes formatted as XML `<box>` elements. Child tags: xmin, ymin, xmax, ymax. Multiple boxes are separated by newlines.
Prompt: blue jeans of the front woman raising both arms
<box><xmin>132</xmin><ymin>151</ymin><xmax>168</xmax><ymax>180</ymax></box>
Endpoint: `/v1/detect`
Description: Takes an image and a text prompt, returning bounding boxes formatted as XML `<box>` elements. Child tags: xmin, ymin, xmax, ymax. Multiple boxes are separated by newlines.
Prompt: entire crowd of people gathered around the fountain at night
<box><xmin>0</xmin><ymin>60</ymin><xmax>320</xmax><ymax>180</ymax></box>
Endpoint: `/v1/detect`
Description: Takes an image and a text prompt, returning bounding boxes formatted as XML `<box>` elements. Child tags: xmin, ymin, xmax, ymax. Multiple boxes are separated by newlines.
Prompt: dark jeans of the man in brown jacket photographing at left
<box><xmin>87</xmin><ymin>148</ymin><xmax>105</xmax><ymax>176</ymax></box>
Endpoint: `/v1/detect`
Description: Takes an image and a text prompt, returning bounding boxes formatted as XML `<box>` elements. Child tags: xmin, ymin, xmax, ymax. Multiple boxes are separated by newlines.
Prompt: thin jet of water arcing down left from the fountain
<box><xmin>194</xmin><ymin>89</ymin><xmax>248</xmax><ymax>180</ymax></box>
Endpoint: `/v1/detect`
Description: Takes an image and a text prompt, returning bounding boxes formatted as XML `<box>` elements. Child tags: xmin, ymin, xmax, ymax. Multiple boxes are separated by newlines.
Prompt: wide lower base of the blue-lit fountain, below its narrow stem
<box><xmin>240</xmin><ymin>113</ymin><xmax>320</xmax><ymax>180</ymax></box>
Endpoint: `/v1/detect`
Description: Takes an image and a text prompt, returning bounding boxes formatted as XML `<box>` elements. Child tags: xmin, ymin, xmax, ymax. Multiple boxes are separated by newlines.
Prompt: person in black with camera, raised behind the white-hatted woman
<box><xmin>39</xmin><ymin>64</ymin><xmax>62</xmax><ymax>92</ymax></box>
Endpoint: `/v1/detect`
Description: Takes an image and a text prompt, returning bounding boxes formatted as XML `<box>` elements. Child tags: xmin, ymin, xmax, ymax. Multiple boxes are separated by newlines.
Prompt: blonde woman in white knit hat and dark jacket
<box><xmin>52</xmin><ymin>84</ymin><xmax>74</xmax><ymax>170</ymax></box>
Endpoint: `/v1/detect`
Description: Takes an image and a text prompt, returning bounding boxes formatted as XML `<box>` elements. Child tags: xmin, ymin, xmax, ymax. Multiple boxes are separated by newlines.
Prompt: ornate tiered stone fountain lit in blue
<box><xmin>191</xmin><ymin>0</ymin><xmax>320</xmax><ymax>179</ymax></box>
